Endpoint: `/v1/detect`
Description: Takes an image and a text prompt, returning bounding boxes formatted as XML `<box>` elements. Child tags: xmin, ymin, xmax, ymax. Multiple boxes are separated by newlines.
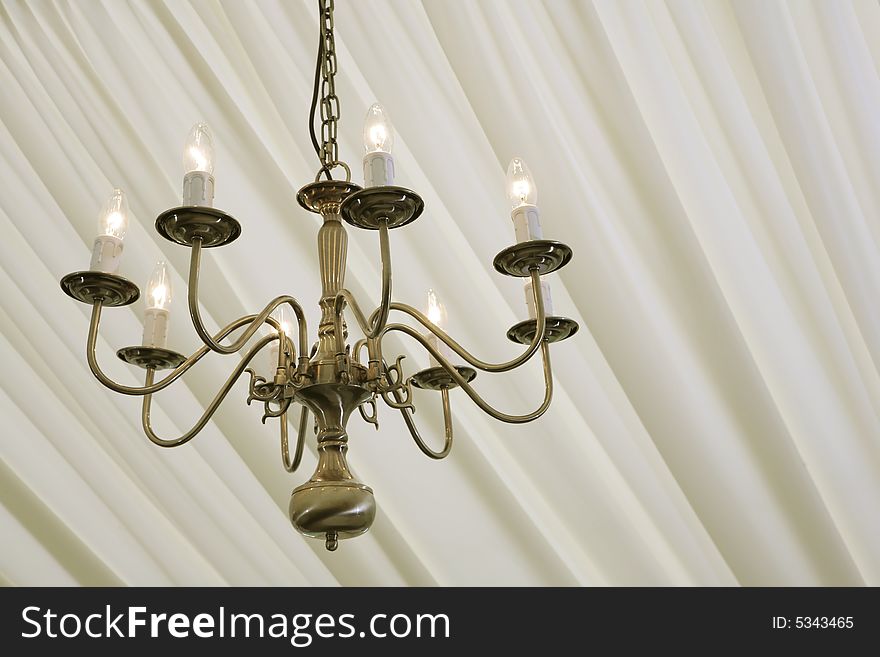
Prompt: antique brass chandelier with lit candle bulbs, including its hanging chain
<box><xmin>61</xmin><ymin>0</ymin><xmax>578</xmax><ymax>550</ymax></box>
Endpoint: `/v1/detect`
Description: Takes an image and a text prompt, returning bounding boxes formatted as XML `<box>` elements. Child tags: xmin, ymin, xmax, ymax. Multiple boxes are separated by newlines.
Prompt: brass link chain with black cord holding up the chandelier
<box><xmin>313</xmin><ymin>0</ymin><xmax>351</xmax><ymax>180</ymax></box>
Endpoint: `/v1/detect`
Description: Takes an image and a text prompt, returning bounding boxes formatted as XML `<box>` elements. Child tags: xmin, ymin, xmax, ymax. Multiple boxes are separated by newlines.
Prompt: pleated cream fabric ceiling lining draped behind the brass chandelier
<box><xmin>0</xmin><ymin>0</ymin><xmax>880</xmax><ymax>586</ymax></box>
